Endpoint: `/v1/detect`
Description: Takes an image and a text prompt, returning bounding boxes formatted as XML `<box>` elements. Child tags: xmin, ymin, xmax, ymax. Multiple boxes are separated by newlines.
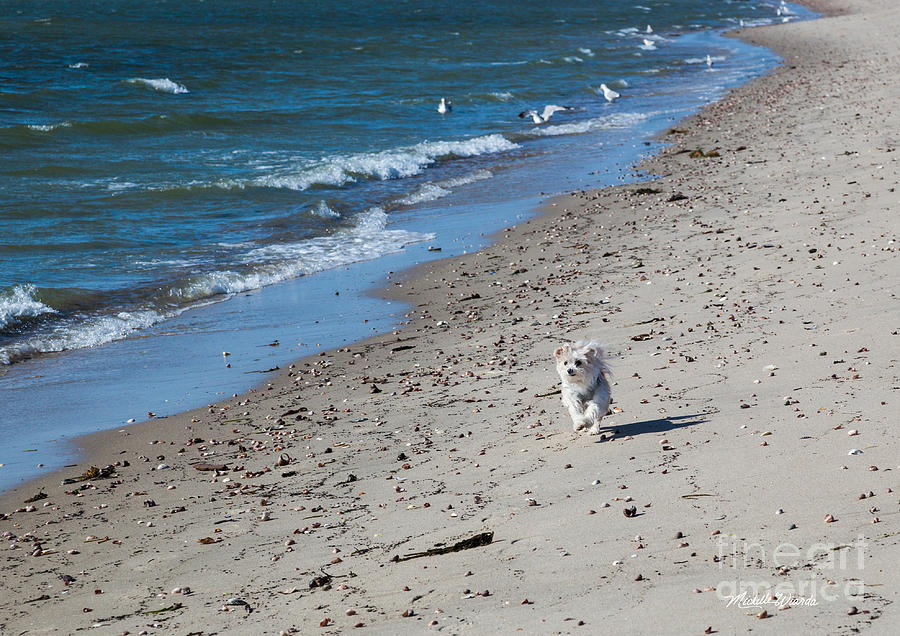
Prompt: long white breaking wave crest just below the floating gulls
<box><xmin>253</xmin><ymin>134</ymin><xmax>518</xmax><ymax>190</ymax></box>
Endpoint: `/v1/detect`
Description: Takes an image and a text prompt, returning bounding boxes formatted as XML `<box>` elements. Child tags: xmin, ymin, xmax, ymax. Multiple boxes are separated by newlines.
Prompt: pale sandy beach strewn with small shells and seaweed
<box><xmin>0</xmin><ymin>0</ymin><xmax>900</xmax><ymax>635</ymax></box>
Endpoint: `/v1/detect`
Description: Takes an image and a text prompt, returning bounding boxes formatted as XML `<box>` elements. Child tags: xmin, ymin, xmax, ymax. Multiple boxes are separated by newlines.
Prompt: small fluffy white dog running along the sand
<box><xmin>554</xmin><ymin>342</ymin><xmax>611</xmax><ymax>435</ymax></box>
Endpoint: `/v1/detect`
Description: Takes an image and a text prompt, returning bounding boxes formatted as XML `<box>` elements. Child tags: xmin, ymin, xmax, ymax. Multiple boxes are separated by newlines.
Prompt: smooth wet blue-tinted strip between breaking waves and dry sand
<box><xmin>0</xmin><ymin>12</ymin><xmax>788</xmax><ymax>490</ymax></box>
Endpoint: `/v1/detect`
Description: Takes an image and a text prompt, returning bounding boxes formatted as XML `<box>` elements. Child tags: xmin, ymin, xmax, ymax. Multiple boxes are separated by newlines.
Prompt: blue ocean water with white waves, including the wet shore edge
<box><xmin>0</xmin><ymin>0</ymin><xmax>811</xmax><ymax>487</ymax></box>
